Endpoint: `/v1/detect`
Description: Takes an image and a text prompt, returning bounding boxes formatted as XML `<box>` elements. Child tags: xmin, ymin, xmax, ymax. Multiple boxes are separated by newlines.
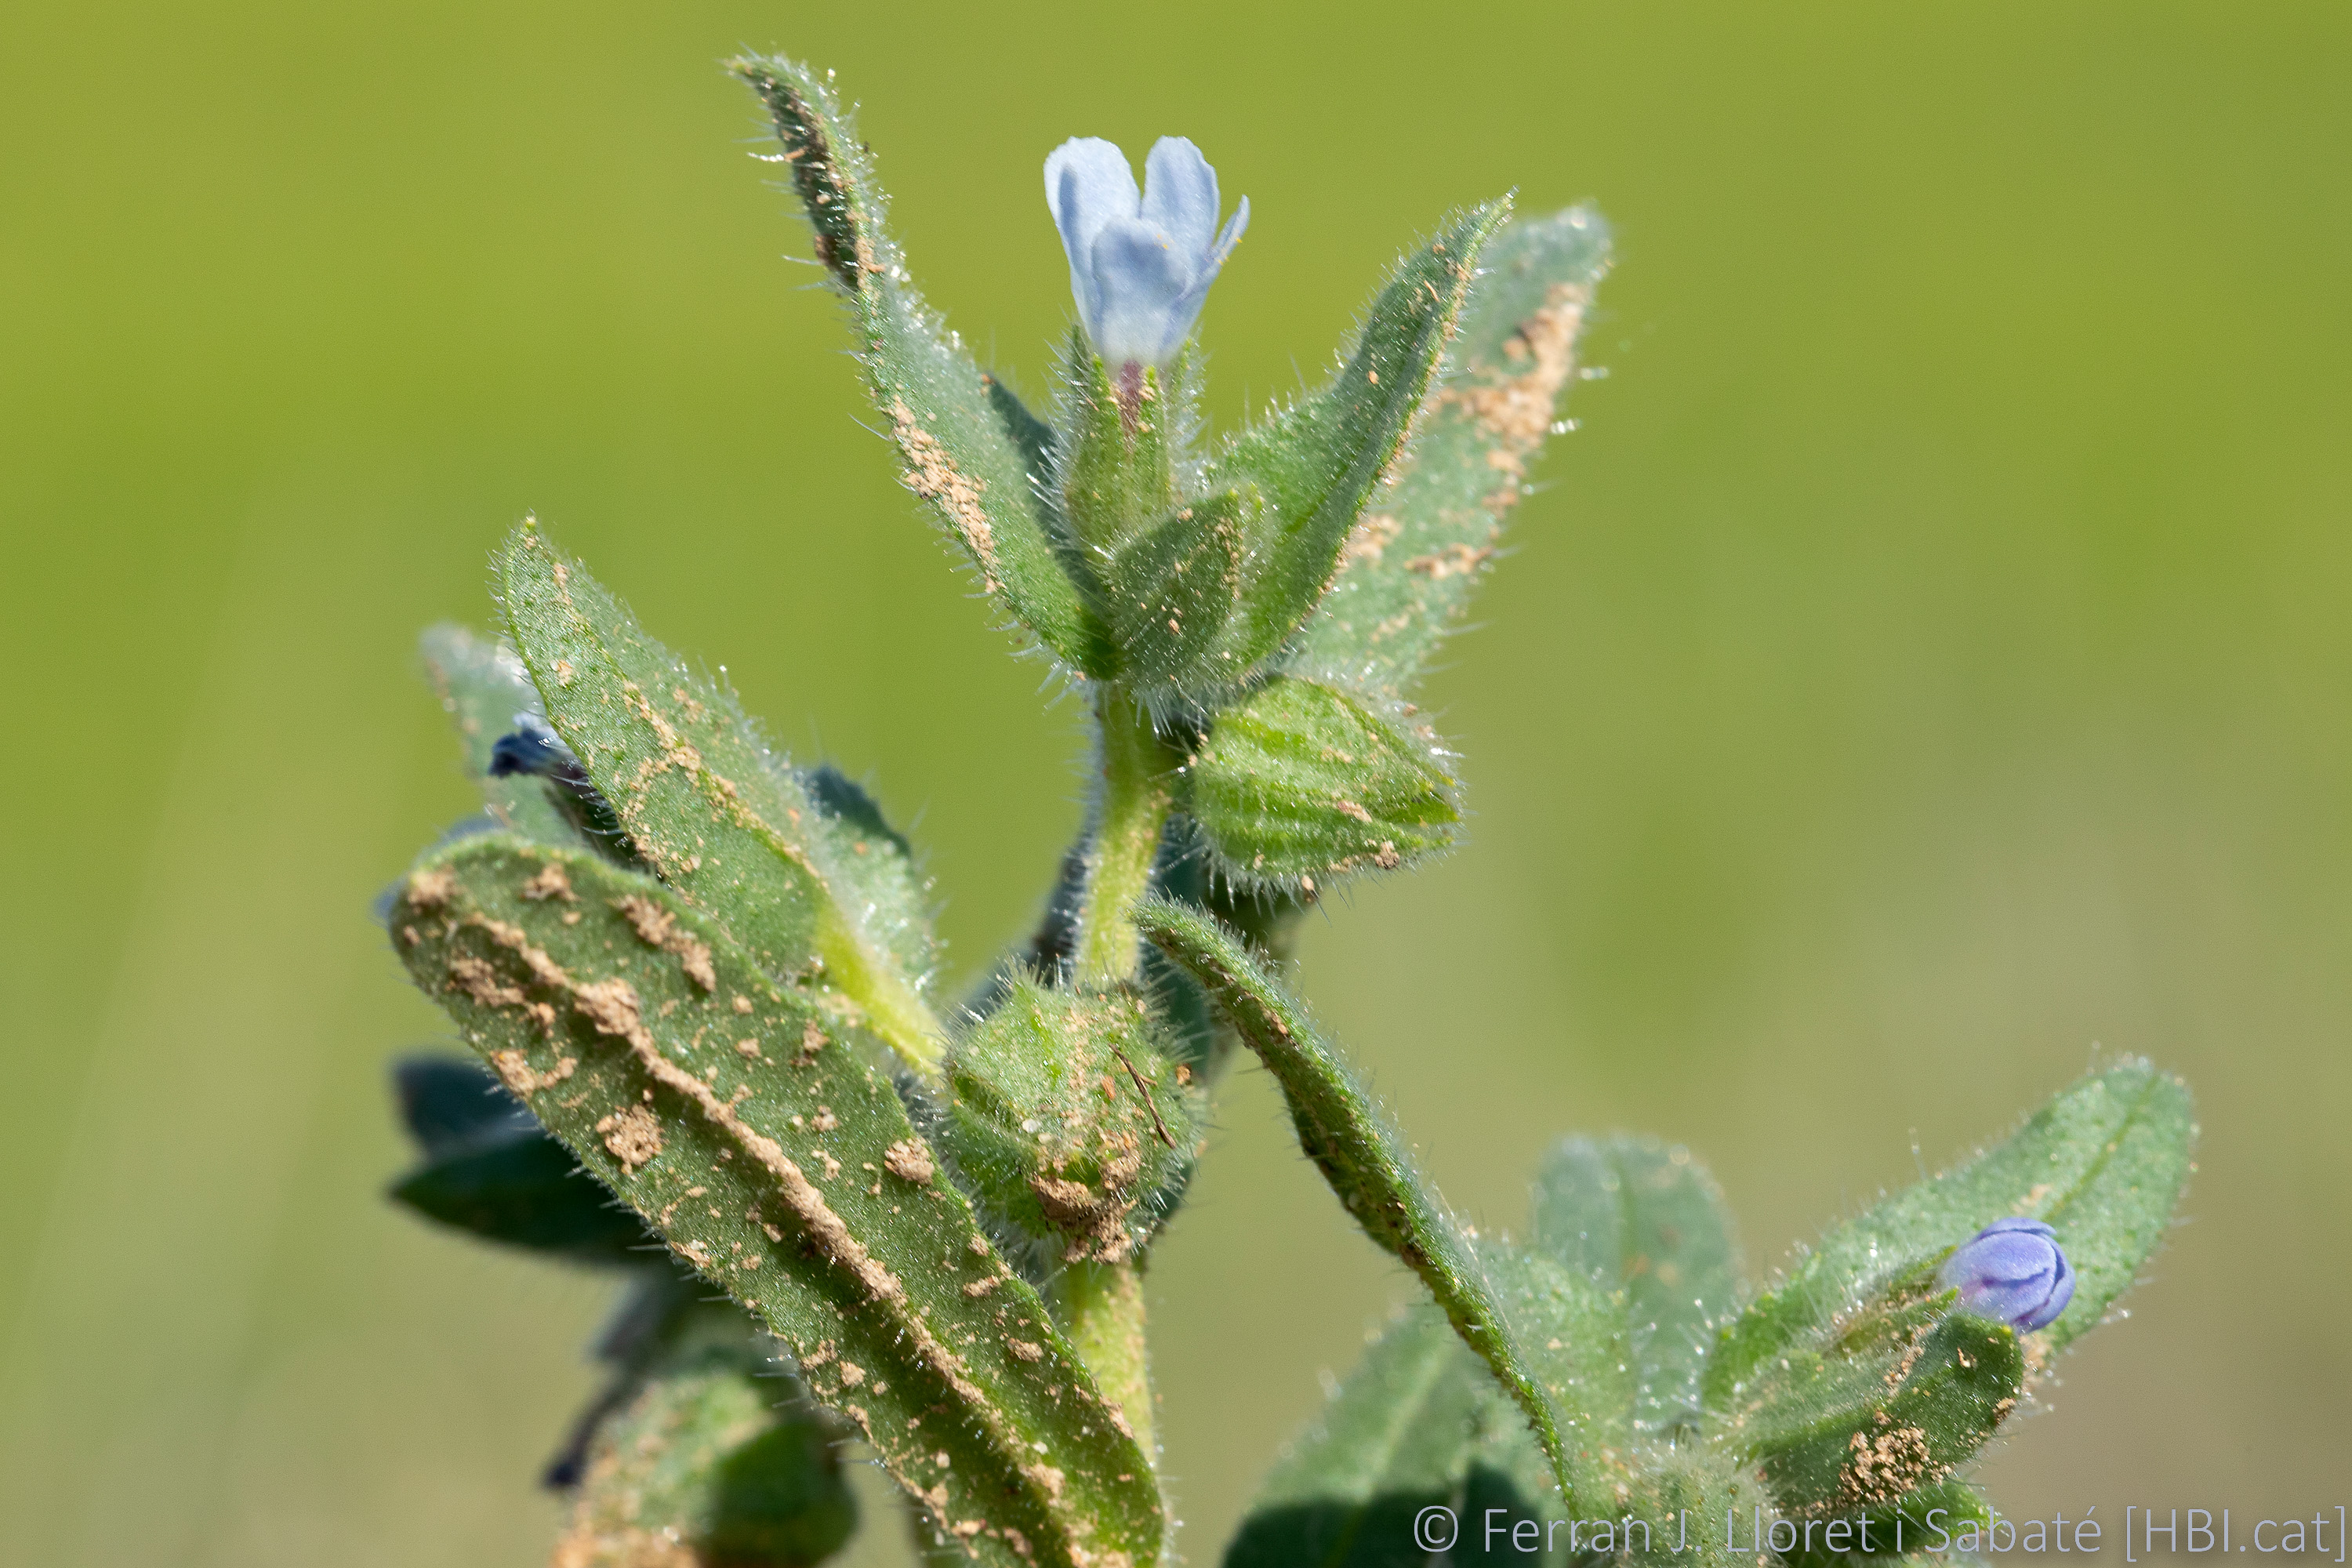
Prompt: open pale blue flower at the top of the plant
<box><xmin>1044</xmin><ymin>136</ymin><xmax>1249</xmax><ymax>367</ymax></box>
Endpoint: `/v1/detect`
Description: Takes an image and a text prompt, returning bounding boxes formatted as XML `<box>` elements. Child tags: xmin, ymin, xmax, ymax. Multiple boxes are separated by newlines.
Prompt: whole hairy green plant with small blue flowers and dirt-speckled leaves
<box><xmin>386</xmin><ymin>59</ymin><xmax>2194</xmax><ymax>1568</ymax></box>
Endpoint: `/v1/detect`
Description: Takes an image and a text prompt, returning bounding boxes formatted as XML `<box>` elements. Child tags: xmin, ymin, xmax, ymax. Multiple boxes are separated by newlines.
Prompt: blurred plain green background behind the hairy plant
<box><xmin>0</xmin><ymin>0</ymin><xmax>2352</xmax><ymax>1568</ymax></box>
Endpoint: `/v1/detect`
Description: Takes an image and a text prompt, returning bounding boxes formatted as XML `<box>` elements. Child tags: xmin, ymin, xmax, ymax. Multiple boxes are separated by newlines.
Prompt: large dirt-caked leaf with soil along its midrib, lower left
<box><xmin>390</xmin><ymin>837</ymin><xmax>1162</xmax><ymax>1568</ymax></box>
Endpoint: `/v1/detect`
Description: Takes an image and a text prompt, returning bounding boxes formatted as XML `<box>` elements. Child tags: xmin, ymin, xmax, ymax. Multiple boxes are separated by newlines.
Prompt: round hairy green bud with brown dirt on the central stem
<box><xmin>936</xmin><ymin>973</ymin><xmax>1200</xmax><ymax>1262</ymax></box>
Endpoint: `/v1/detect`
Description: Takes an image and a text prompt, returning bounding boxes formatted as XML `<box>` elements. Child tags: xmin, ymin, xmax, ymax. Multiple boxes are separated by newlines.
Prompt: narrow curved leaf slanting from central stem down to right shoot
<box><xmin>1136</xmin><ymin>898</ymin><xmax>1632</xmax><ymax>1512</ymax></box>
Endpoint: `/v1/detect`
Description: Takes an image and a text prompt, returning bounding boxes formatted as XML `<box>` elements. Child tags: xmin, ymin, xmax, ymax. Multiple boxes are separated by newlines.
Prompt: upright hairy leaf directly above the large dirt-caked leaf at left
<box><xmin>499</xmin><ymin>524</ymin><xmax>946</xmax><ymax>1074</ymax></box>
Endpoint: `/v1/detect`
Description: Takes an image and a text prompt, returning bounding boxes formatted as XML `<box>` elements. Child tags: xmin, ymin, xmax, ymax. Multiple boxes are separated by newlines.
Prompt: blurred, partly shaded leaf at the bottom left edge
<box><xmin>555</xmin><ymin>1307</ymin><xmax>858</xmax><ymax>1568</ymax></box>
